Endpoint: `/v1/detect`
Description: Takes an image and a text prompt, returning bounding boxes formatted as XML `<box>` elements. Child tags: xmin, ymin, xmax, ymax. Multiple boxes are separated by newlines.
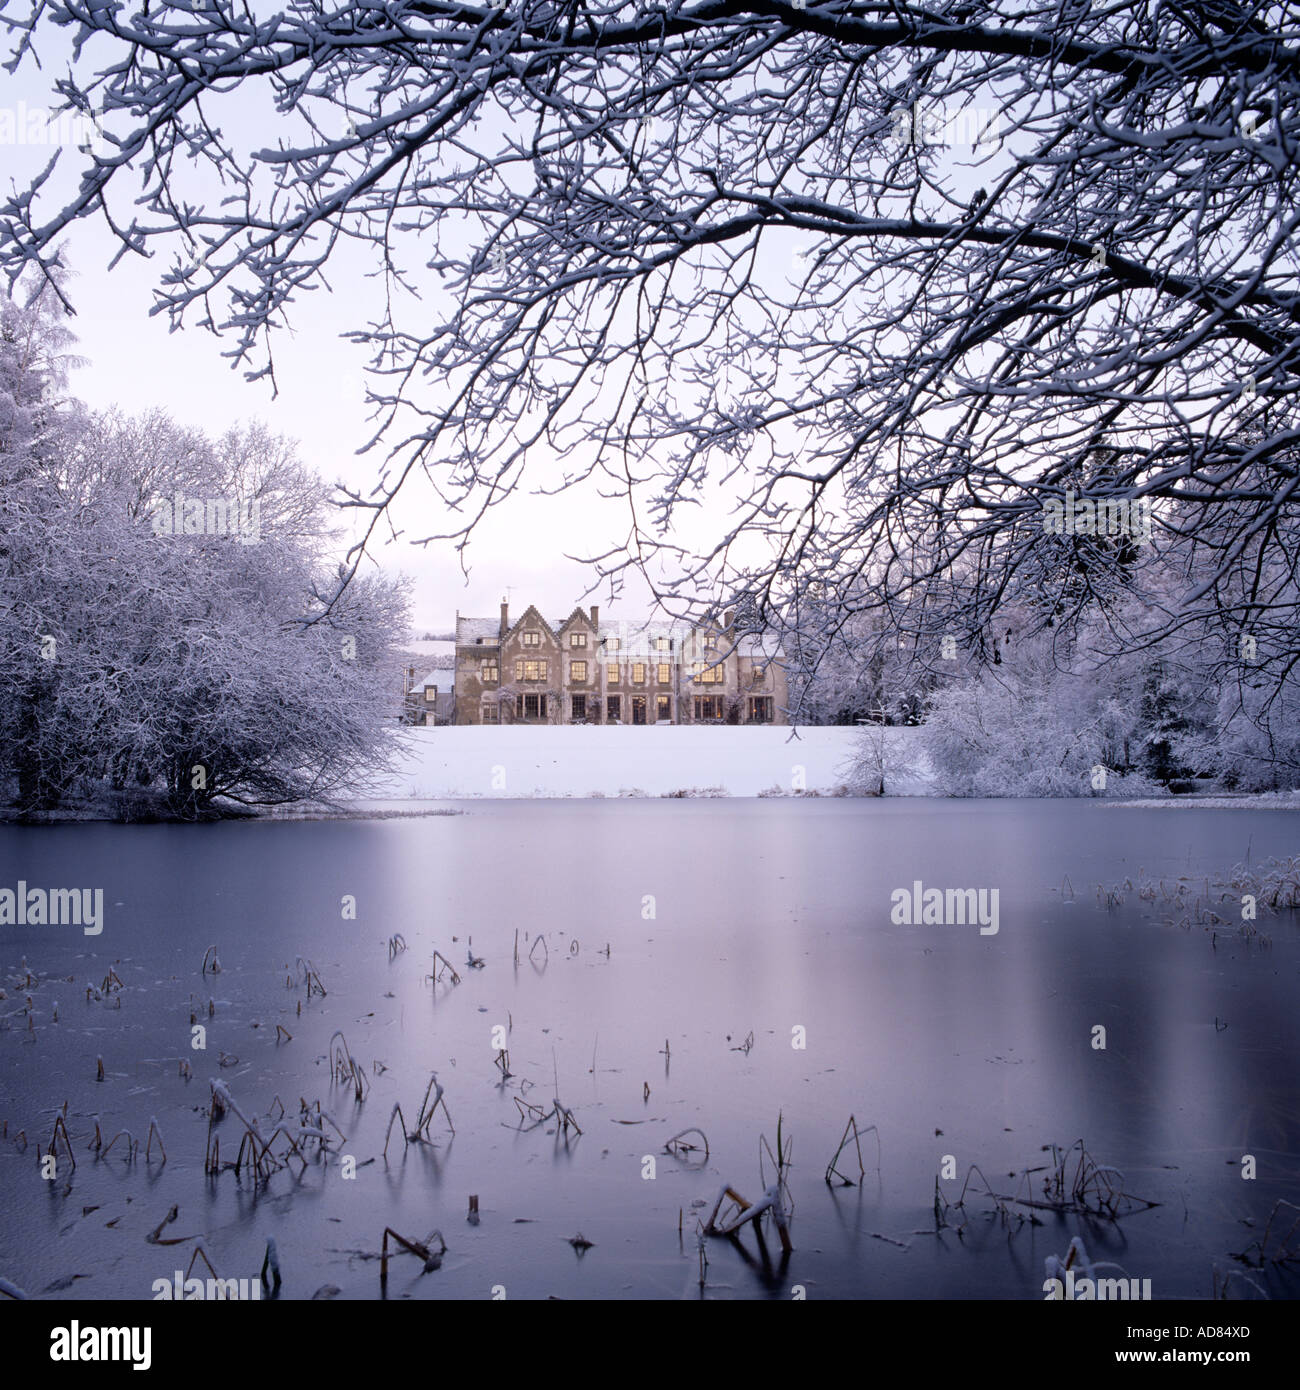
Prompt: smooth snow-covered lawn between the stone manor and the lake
<box><xmin>366</xmin><ymin>724</ymin><xmax>925</xmax><ymax>801</ymax></box>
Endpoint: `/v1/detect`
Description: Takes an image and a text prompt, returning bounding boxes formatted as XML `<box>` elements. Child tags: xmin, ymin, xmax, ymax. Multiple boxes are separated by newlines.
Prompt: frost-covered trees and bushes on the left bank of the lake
<box><xmin>0</xmin><ymin>289</ymin><xmax>406</xmax><ymax>816</ymax></box>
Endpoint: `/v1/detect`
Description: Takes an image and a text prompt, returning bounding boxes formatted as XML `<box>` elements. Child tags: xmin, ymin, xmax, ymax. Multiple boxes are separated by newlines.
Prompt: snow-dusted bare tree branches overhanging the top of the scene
<box><xmin>0</xmin><ymin>0</ymin><xmax>1300</xmax><ymax>705</ymax></box>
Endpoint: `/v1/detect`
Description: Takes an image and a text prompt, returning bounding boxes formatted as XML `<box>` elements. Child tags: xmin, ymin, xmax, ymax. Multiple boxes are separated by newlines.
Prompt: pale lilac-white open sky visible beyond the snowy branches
<box><xmin>0</xmin><ymin>40</ymin><xmax>984</xmax><ymax>631</ymax></box>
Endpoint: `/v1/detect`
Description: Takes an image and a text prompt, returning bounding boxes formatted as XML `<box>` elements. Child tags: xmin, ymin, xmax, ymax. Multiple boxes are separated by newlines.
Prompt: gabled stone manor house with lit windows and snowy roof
<box><xmin>455</xmin><ymin>603</ymin><xmax>788</xmax><ymax>724</ymax></box>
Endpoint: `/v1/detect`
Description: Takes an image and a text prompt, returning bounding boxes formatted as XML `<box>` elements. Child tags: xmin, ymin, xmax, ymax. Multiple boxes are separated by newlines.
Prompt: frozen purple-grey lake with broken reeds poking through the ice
<box><xmin>0</xmin><ymin>799</ymin><xmax>1300</xmax><ymax>1298</ymax></box>
